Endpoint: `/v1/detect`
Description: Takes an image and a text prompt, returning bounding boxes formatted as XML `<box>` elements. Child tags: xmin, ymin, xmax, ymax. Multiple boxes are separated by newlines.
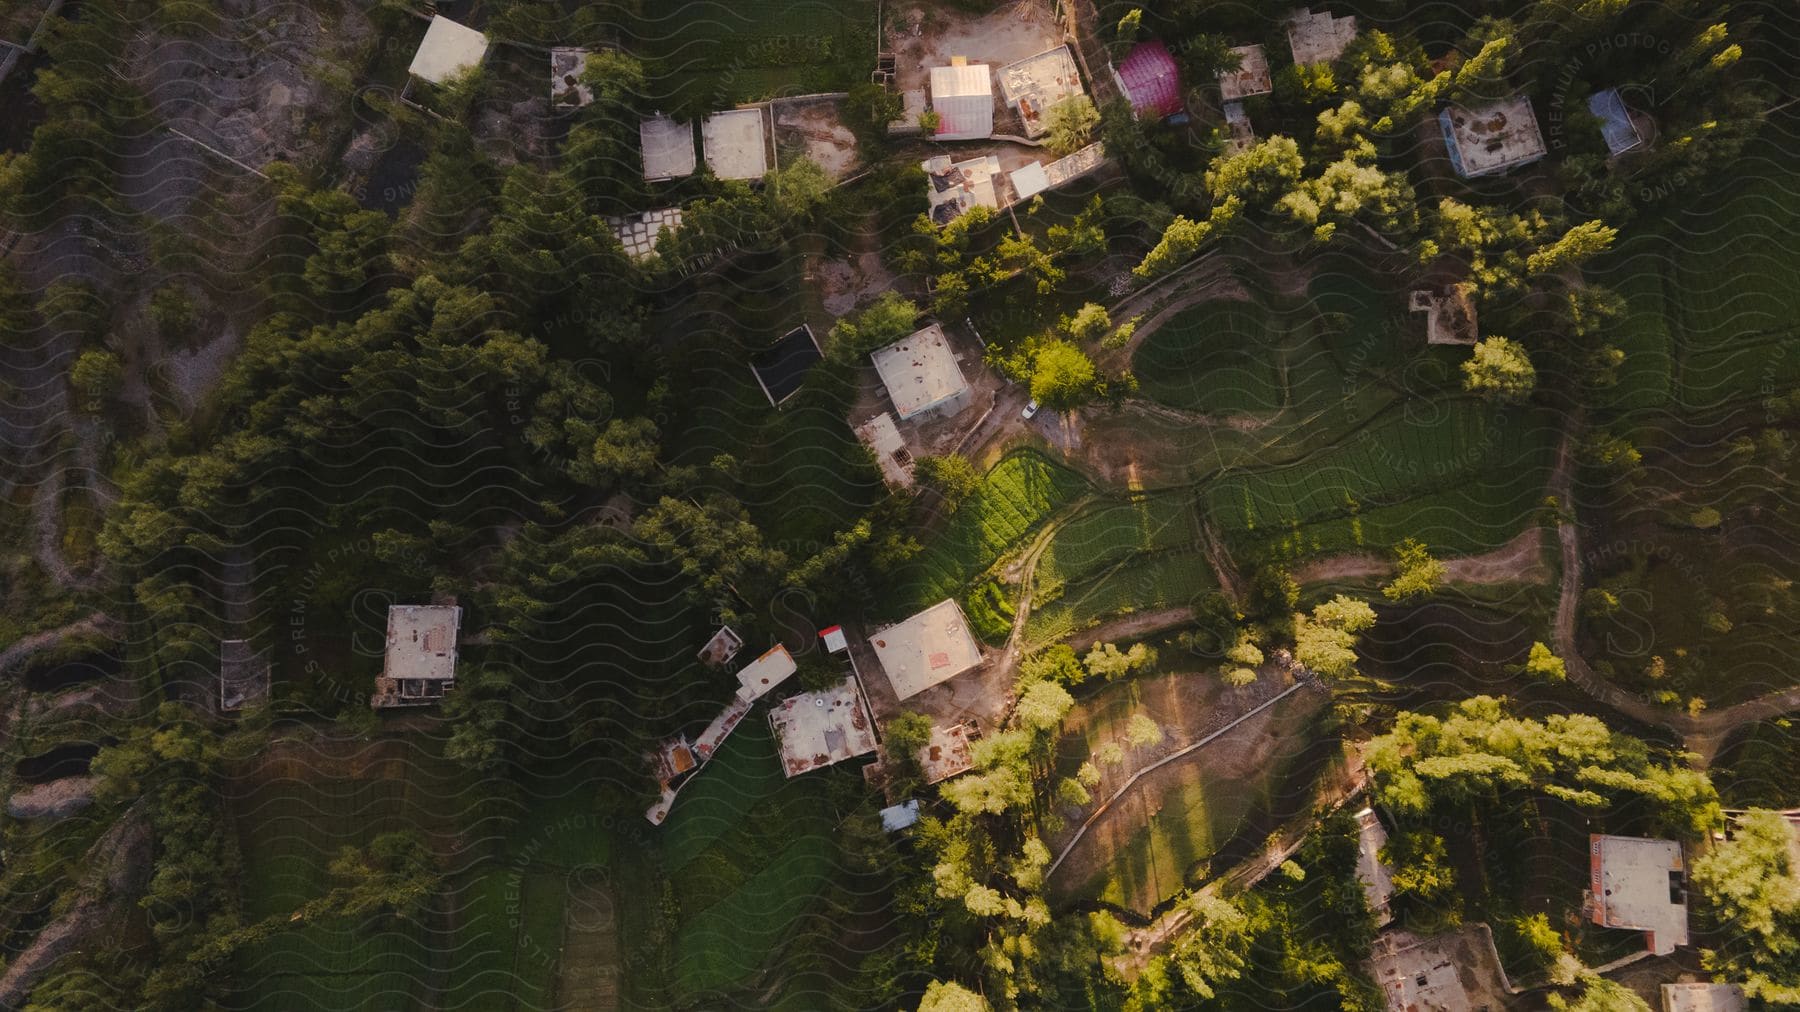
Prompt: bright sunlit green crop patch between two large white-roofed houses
<box><xmin>895</xmin><ymin>450</ymin><xmax>1087</xmax><ymax>616</ymax></box>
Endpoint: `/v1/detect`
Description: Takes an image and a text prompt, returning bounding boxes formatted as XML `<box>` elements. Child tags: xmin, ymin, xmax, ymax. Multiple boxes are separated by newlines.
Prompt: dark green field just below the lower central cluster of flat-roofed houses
<box><xmin>662</xmin><ymin>717</ymin><xmax>855</xmax><ymax>994</ymax></box>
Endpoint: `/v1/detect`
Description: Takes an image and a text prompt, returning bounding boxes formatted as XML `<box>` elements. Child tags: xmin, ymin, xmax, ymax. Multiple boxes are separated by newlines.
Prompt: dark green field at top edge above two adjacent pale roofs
<box><xmin>623</xmin><ymin>0</ymin><xmax>878</xmax><ymax>110</ymax></box>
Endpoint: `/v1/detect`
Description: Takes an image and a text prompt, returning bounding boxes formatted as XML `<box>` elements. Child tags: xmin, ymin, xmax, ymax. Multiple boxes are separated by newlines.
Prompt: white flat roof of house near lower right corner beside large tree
<box><xmin>1588</xmin><ymin>836</ymin><xmax>1688</xmax><ymax>956</ymax></box>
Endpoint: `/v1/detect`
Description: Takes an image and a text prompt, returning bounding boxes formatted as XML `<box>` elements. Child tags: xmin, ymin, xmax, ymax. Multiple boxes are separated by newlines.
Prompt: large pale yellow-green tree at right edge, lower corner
<box><xmin>1694</xmin><ymin>810</ymin><xmax>1800</xmax><ymax>1005</ymax></box>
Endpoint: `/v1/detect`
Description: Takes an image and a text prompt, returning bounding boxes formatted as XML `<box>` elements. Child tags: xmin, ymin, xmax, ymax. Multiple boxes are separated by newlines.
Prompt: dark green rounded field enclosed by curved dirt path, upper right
<box><xmin>1132</xmin><ymin>303</ymin><xmax>1285</xmax><ymax>414</ymax></box>
